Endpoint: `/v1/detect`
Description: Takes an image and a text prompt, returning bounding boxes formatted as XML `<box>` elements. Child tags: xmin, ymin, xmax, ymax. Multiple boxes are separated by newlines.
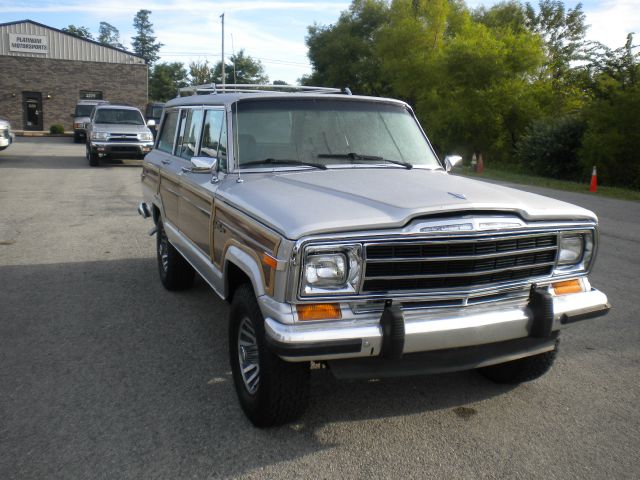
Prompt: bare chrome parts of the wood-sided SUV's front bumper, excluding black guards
<box><xmin>265</xmin><ymin>289</ymin><xmax>609</xmax><ymax>361</ymax></box>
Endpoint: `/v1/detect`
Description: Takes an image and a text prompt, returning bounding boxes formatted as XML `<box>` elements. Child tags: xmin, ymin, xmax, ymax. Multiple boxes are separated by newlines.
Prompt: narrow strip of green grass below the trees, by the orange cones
<box><xmin>455</xmin><ymin>167</ymin><xmax>640</xmax><ymax>201</ymax></box>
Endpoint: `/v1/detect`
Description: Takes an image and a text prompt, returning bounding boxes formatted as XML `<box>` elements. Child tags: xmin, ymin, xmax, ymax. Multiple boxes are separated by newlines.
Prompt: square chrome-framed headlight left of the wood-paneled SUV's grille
<box><xmin>300</xmin><ymin>245</ymin><xmax>362</xmax><ymax>295</ymax></box>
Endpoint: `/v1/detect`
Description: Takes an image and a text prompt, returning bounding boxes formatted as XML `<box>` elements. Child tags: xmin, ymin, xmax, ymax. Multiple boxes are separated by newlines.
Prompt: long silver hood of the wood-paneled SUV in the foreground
<box><xmin>220</xmin><ymin>168</ymin><xmax>596</xmax><ymax>240</ymax></box>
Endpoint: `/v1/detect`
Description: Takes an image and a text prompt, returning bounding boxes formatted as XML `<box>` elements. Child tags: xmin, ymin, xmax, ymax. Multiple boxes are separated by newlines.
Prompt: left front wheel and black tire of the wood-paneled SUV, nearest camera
<box><xmin>229</xmin><ymin>284</ymin><xmax>309</xmax><ymax>427</ymax></box>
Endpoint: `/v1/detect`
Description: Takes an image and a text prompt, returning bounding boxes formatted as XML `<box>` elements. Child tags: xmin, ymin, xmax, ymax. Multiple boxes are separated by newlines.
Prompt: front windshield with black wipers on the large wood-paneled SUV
<box><xmin>232</xmin><ymin>98</ymin><xmax>440</xmax><ymax>168</ymax></box>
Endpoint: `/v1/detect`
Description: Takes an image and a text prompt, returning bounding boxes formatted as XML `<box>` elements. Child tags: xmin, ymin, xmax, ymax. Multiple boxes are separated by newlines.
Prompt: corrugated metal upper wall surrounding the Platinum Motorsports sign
<box><xmin>0</xmin><ymin>22</ymin><xmax>144</xmax><ymax>64</ymax></box>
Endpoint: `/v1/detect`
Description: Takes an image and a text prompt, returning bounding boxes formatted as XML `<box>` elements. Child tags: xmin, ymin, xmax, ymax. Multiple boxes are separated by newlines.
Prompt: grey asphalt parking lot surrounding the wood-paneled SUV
<box><xmin>0</xmin><ymin>138</ymin><xmax>640</xmax><ymax>479</ymax></box>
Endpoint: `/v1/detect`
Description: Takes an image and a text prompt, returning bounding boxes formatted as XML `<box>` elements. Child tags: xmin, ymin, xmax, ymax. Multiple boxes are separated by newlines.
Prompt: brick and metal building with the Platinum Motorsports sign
<box><xmin>0</xmin><ymin>20</ymin><xmax>148</xmax><ymax>130</ymax></box>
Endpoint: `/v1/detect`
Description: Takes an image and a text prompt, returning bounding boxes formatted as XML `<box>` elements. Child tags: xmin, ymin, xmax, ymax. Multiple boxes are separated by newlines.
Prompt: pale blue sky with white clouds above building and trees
<box><xmin>0</xmin><ymin>0</ymin><xmax>640</xmax><ymax>83</ymax></box>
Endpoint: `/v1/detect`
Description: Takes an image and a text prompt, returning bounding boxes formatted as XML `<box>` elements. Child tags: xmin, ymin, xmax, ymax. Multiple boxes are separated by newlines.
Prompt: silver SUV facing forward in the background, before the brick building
<box><xmin>86</xmin><ymin>104</ymin><xmax>153</xmax><ymax>167</ymax></box>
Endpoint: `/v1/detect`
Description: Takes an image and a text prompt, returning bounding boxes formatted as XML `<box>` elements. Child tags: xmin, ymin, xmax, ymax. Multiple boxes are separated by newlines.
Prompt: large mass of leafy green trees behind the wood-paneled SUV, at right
<box><xmin>301</xmin><ymin>0</ymin><xmax>640</xmax><ymax>185</ymax></box>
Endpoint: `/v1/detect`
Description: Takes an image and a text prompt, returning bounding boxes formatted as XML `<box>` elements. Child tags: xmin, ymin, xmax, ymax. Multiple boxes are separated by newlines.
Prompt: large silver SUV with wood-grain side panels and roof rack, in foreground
<box><xmin>138</xmin><ymin>86</ymin><xmax>609</xmax><ymax>426</ymax></box>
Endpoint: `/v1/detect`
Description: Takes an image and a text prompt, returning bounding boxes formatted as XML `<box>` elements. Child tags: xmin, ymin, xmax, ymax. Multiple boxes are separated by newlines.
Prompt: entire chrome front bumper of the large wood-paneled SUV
<box><xmin>262</xmin><ymin>289</ymin><xmax>610</xmax><ymax>362</ymax></box>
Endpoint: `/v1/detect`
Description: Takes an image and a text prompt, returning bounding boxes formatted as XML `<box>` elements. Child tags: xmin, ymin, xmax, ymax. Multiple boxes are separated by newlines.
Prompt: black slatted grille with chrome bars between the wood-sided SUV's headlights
<box><xmin>362</xmin><ymin>233</ymin><xmax>558</xmax><ymax>293</ymax></box>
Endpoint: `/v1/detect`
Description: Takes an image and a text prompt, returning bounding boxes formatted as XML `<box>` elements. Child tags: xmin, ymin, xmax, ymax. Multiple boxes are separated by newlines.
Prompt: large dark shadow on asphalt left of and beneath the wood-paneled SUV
<box><xmin>0</xmin><ymin>258</ymin><xmax>507</xmax><ymax>478</ymax></box>
